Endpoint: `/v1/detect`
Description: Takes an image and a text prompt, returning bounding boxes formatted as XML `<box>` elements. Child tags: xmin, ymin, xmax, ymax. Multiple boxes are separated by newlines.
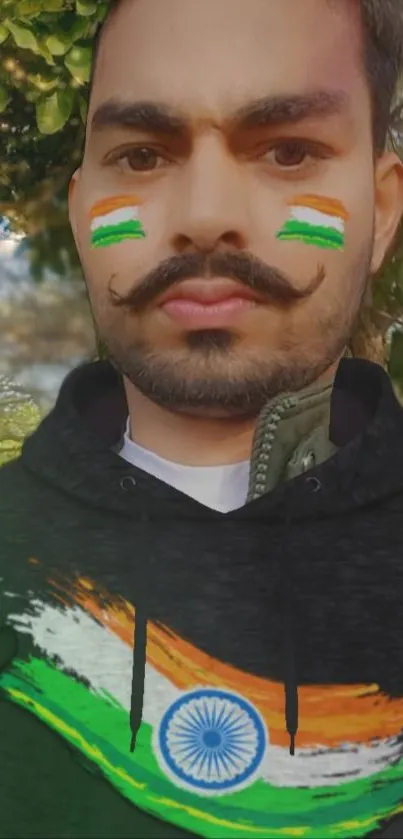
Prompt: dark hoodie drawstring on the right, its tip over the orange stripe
<box><xmin>282</xmin><ymin>511</ymin><xmax>298</xmax><ymax>756</ymax></box>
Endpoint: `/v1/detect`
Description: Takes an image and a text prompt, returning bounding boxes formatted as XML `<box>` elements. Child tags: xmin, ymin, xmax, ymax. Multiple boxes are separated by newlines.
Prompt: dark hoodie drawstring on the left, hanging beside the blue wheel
<box><xmin>130</xmin><ymin>513</ymin><xmax>151</xmax><ymax>752</ymax></box>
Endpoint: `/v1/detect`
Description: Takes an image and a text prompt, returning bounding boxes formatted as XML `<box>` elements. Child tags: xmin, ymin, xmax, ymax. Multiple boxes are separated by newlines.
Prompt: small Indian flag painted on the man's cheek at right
<box><xmin>276</xmin><ymin>195</ymin><xmax>349</xmax><ymax>250</ymax></box>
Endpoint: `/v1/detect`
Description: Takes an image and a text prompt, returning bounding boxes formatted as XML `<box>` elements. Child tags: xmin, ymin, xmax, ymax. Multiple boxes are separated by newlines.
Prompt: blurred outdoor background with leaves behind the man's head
<box><xmin>0</xmin><ymin>0</ymin><xmax>403</xmax><ymax>414</ymax></box>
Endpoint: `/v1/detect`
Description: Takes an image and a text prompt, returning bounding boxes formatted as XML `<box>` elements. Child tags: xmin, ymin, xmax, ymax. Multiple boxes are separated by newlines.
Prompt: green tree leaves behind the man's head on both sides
<box><xmin>0</xmin><ymin>0</ymin><xmax>403</xmax><ymax>374</ymax></box>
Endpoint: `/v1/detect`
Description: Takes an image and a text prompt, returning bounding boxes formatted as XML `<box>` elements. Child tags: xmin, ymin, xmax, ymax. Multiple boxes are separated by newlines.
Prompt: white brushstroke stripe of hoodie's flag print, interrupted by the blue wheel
<box><xmin>9</xmin><ymin>600</ymin><xmax>403</xmax><ymax>788</ymax></box>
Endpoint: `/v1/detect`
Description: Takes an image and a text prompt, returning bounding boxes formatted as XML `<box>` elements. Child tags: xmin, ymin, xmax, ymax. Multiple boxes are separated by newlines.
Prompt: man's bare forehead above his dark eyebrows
<box><xmin>90</xmin><ymin>0</ymin><xmax>369</xmax><ymax>124</ymax></box>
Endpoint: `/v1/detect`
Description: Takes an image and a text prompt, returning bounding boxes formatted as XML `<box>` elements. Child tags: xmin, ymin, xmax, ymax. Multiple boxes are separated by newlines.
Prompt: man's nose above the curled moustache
<box><xmin>167</xmin><ymin>136</ymin><xmax>248</xmax><ymax>253</ymax></box>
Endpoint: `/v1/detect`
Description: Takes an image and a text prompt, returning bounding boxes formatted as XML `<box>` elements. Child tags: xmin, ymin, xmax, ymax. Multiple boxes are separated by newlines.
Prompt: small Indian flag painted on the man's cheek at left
<box><xmin>90</xmin><ymin>195</ymin><xmax>146</xmax><ymax>248</ymax></box>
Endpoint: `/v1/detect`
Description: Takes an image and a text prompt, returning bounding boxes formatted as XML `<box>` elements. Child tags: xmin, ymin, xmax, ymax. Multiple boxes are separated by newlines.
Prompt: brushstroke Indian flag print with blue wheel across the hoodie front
<box><xmin>0</xmin><ymin>579</ymin><xmax>403</xmax><ymax>839</ymax></box>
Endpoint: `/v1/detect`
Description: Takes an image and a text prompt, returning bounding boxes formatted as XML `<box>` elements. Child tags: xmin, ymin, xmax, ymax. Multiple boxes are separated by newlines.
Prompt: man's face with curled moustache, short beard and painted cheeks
<box><xmin>71</xmin><ymin>0</ymin><xmax>394</xmax><ymax>417</ymax></box>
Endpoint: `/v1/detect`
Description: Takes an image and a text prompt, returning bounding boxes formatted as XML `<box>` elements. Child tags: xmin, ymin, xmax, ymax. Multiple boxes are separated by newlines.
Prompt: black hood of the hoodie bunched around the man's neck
<box><xmin>21</xmin><ymin>358</ymin><xmax>403</xmax><ymax>520</ymax></box>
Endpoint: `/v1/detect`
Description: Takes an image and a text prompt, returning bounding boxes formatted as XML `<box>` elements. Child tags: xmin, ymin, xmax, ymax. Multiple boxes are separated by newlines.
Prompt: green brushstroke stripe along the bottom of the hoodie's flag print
<box><xmin>0</xmin><ymin>659</ymin><xmax>403</xmax><ymax>839</ymax></box>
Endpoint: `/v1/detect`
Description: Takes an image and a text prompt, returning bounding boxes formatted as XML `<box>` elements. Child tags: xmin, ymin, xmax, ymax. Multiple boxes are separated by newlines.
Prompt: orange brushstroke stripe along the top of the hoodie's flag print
<box><xmin>54</xmin><ymin>579</ymin><xmax>403</xmax><ymax>748</ymax></box>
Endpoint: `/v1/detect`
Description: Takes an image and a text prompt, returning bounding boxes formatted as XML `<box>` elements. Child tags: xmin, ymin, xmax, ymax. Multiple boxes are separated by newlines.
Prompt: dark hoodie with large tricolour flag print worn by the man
<box><xmin>0</xmin><ymin>359</ymin><xmax>403</xmax><ymax>839</ymax></box>
